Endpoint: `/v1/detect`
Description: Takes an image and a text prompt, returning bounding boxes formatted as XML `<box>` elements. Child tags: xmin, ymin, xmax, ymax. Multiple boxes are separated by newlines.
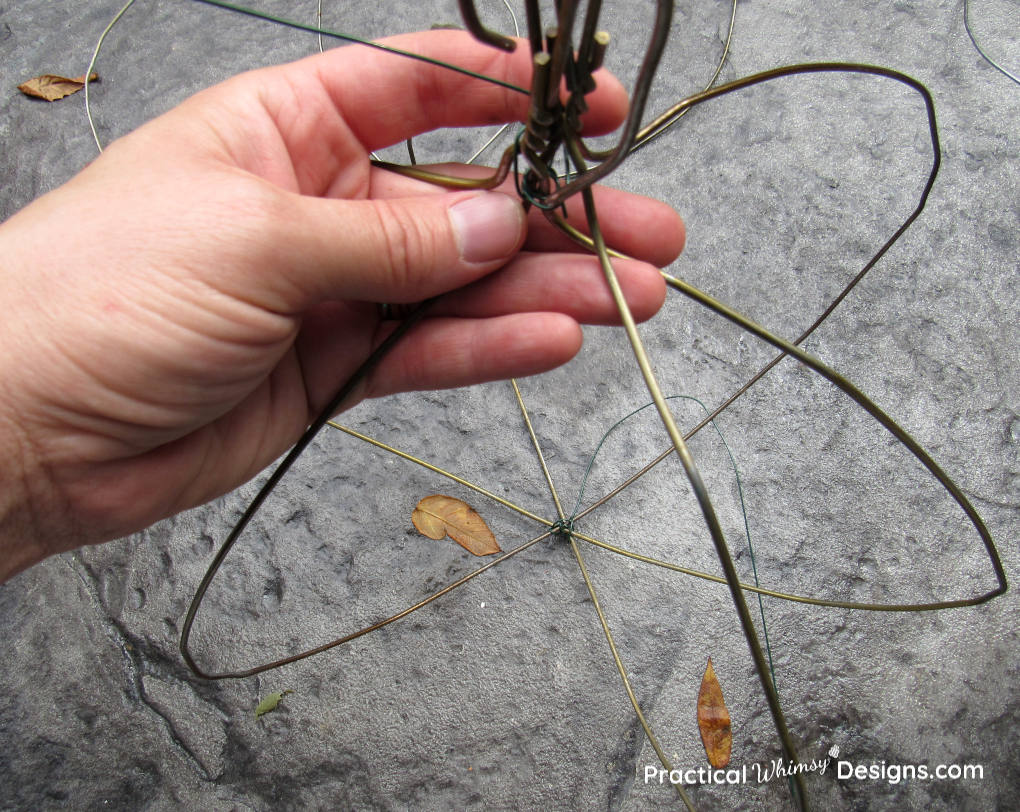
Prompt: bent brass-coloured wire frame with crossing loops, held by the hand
<box><xmin>163</xmin><ymin>0</ymin><xmax>1007</xmax><ymax>809</ymax></box>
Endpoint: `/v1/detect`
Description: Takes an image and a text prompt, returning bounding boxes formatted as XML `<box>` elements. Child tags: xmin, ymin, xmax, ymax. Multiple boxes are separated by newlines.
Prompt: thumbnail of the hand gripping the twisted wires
<box><xmin>448</xmin><ymin>192</ymin><xmax>524</xmax><ymax>262</ymax></box>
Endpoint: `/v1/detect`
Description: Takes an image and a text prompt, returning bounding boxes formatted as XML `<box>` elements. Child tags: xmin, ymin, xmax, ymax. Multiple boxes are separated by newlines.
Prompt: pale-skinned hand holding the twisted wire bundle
<box><xmin>0</xmin><ymin>32</ymin><xmax>683</xmax><ymax>580</ymax></box>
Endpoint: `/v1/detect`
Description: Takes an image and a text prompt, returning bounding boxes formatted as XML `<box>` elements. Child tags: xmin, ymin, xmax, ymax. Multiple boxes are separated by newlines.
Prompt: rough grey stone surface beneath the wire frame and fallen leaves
<box><xmin>0</xmin><ymin>0</ymin><xmax>1020</xmax><ymax>810</ymax></box>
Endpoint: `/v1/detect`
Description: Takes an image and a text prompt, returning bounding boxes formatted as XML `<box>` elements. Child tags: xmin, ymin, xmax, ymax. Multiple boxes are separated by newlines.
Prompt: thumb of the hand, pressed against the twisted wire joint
<box><xmin>263</xmin><ymin>192</ymin><xmax>526</xmax><ymax>311</ymax></box>
